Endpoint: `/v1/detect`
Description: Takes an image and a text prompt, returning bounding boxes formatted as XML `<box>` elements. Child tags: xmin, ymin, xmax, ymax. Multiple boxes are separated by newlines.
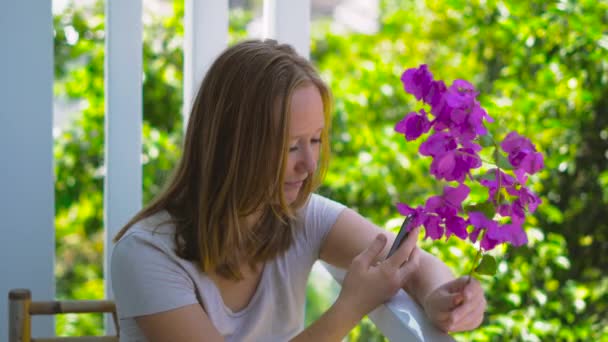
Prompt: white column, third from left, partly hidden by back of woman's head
<box><xmin>183</xmin><ymin>0</ymin><xmax>229</xmax><ymax>129</ymax></box>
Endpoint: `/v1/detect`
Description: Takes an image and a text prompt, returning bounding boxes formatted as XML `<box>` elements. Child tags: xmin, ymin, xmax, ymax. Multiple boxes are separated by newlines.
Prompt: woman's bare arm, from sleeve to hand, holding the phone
<box><xmin>135</xmin><ymin>234</ymin><xmax>416</xmax><ymax>342</ymax></box>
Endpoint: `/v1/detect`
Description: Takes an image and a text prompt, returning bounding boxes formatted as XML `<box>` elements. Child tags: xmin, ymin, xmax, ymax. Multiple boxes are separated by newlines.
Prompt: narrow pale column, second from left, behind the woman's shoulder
<box><xmin>104</xmin><ymin>0</ymin><xmax>143</xmax><ymax>327</ymax></box>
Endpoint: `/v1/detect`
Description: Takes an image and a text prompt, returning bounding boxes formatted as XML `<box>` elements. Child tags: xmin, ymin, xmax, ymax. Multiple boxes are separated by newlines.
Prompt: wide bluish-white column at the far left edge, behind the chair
<box><xmin>0</xmin><ymin>0</ymin><xmax>55</xmax><ymax>341</ymax></box>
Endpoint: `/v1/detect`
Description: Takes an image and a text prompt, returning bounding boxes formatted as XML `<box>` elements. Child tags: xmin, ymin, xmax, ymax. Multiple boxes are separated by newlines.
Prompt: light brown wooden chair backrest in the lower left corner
<box><xmin>8</xmin><ymin>289</ymin><xmax>119</xmax><ymax>342</ymax></box>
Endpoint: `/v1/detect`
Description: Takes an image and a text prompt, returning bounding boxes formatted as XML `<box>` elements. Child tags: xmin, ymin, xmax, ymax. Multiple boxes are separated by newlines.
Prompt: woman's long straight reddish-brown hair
<box><xmin>114</xmin><ymin>40</ymin><xmax>331</xmax><ymax>280</ymax></box>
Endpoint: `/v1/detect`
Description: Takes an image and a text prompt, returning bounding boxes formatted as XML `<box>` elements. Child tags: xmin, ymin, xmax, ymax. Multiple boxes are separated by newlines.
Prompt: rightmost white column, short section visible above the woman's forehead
<box><xmin>263</xmin><ymin>0</ymin><xmax>310</xmax><ymax>58</ymax></box>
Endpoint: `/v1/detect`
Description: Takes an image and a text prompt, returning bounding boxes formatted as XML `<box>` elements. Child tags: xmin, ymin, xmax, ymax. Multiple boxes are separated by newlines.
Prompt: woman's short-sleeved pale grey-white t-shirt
<box><xmin>111</xmin><ymin>194</ymin><xmax>344</xmax><ymax>341</ymax></box>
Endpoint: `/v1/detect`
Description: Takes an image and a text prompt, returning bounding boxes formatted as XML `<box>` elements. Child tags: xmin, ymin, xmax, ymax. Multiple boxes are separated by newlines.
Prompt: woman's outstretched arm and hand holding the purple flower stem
<box><xmin>321</xmin><ymin>209</ymin><xmax>486</xmax><ymax>331</ymax></box>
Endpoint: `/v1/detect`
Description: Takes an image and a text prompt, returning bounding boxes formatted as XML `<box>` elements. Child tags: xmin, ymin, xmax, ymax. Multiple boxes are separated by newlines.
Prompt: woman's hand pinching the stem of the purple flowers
<box><xmin>422</xmin><ymin>276</ymin><xmax>487</xmax><ymax>332</ymax></box>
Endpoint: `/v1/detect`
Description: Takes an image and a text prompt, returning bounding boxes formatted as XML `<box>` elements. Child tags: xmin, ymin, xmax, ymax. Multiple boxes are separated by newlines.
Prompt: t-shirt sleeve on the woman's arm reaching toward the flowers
<box><xmin>304</xmin><ymin>194</ymin><xmax>346</xmax><ymax>259</ymax></box>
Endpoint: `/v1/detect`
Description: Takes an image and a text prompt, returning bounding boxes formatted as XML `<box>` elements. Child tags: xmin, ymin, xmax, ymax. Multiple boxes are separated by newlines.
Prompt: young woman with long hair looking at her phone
<box><xmin>111</xmin><ymin>40</ymin><xmax>486</xmax><ymax>341</ymax></box>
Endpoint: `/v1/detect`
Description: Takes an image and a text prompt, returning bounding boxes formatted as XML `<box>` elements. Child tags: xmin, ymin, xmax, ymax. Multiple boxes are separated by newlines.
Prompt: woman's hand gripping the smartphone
<box><xmin>338</xmin><ymin>228</ymin><xmax>420</xmax><ymax>317</ymax></box>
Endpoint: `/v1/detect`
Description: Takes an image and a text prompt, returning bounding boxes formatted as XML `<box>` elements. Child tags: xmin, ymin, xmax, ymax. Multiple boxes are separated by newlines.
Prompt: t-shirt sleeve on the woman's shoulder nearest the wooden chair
<box><xmin>110</xmin><ymin>232</ymin><xmax>198</xmax><ymax>318</ymax></box>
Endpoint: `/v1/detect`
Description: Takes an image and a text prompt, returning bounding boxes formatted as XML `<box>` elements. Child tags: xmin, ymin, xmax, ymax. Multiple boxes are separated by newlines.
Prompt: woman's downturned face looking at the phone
<box><xmin>283</xmin><ymin>84</ymin><xmax>325</xmax><ymax>203</ymax></box>
